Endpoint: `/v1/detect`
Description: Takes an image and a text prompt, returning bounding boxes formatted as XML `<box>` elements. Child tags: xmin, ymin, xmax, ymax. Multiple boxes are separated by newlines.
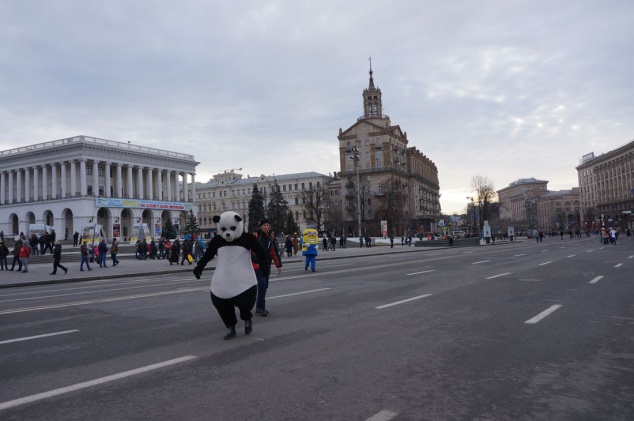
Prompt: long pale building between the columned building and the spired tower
<box><xmin>196</xmin><ymin>170</ymin><xmax>333</xmax><ymax>233</ymax></box>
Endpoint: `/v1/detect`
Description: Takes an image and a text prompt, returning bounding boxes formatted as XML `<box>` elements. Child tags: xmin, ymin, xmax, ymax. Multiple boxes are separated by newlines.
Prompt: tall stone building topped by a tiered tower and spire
<box><xmin>338</xmin><ymin>67</ymin><xmax>440</xmax><ymax>236</ymax></box>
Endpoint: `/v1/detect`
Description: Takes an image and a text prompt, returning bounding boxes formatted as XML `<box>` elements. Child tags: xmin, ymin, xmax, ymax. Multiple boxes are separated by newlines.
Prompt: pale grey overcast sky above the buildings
<box><xmin>0</xmin><ymin>0</ymin><xmax>634</xmax><ymax>213</ymax></box>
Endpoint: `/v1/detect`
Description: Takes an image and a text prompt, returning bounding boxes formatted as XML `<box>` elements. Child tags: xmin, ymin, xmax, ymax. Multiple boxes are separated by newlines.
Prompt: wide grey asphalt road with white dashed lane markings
<box><xmin>0</xmin><ymin>237</ymin><xmax>634</xmax><ymax>421</ymax></box>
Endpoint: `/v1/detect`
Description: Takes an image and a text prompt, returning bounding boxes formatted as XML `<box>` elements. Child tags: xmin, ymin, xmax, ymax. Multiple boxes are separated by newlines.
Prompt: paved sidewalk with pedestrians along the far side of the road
<box><xmin>0</xmin><ymin>243</ymin><xmax>430</xmax><ymax>288</ymax></box>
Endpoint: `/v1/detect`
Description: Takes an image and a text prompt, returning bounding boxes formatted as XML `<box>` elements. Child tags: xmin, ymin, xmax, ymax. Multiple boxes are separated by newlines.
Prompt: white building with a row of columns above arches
<box><xmin>0</xmin><ymin>136</ymin><xmax>198</xmax><ymax>241</ymax></box>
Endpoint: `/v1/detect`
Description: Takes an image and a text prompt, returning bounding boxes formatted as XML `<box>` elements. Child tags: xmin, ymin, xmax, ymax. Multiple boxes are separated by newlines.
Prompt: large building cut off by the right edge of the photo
<box><xmin>577</xmin><ymin>141</ymin><xmax>634</xmax><ymax>229</ymax></box>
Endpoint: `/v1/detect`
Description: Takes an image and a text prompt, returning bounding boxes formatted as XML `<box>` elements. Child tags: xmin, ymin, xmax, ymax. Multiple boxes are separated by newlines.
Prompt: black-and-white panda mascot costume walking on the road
<box><xmin>194</xmin><ymin>211</ymin><xmax>264</xmax><ymax>339</ymax></box>
